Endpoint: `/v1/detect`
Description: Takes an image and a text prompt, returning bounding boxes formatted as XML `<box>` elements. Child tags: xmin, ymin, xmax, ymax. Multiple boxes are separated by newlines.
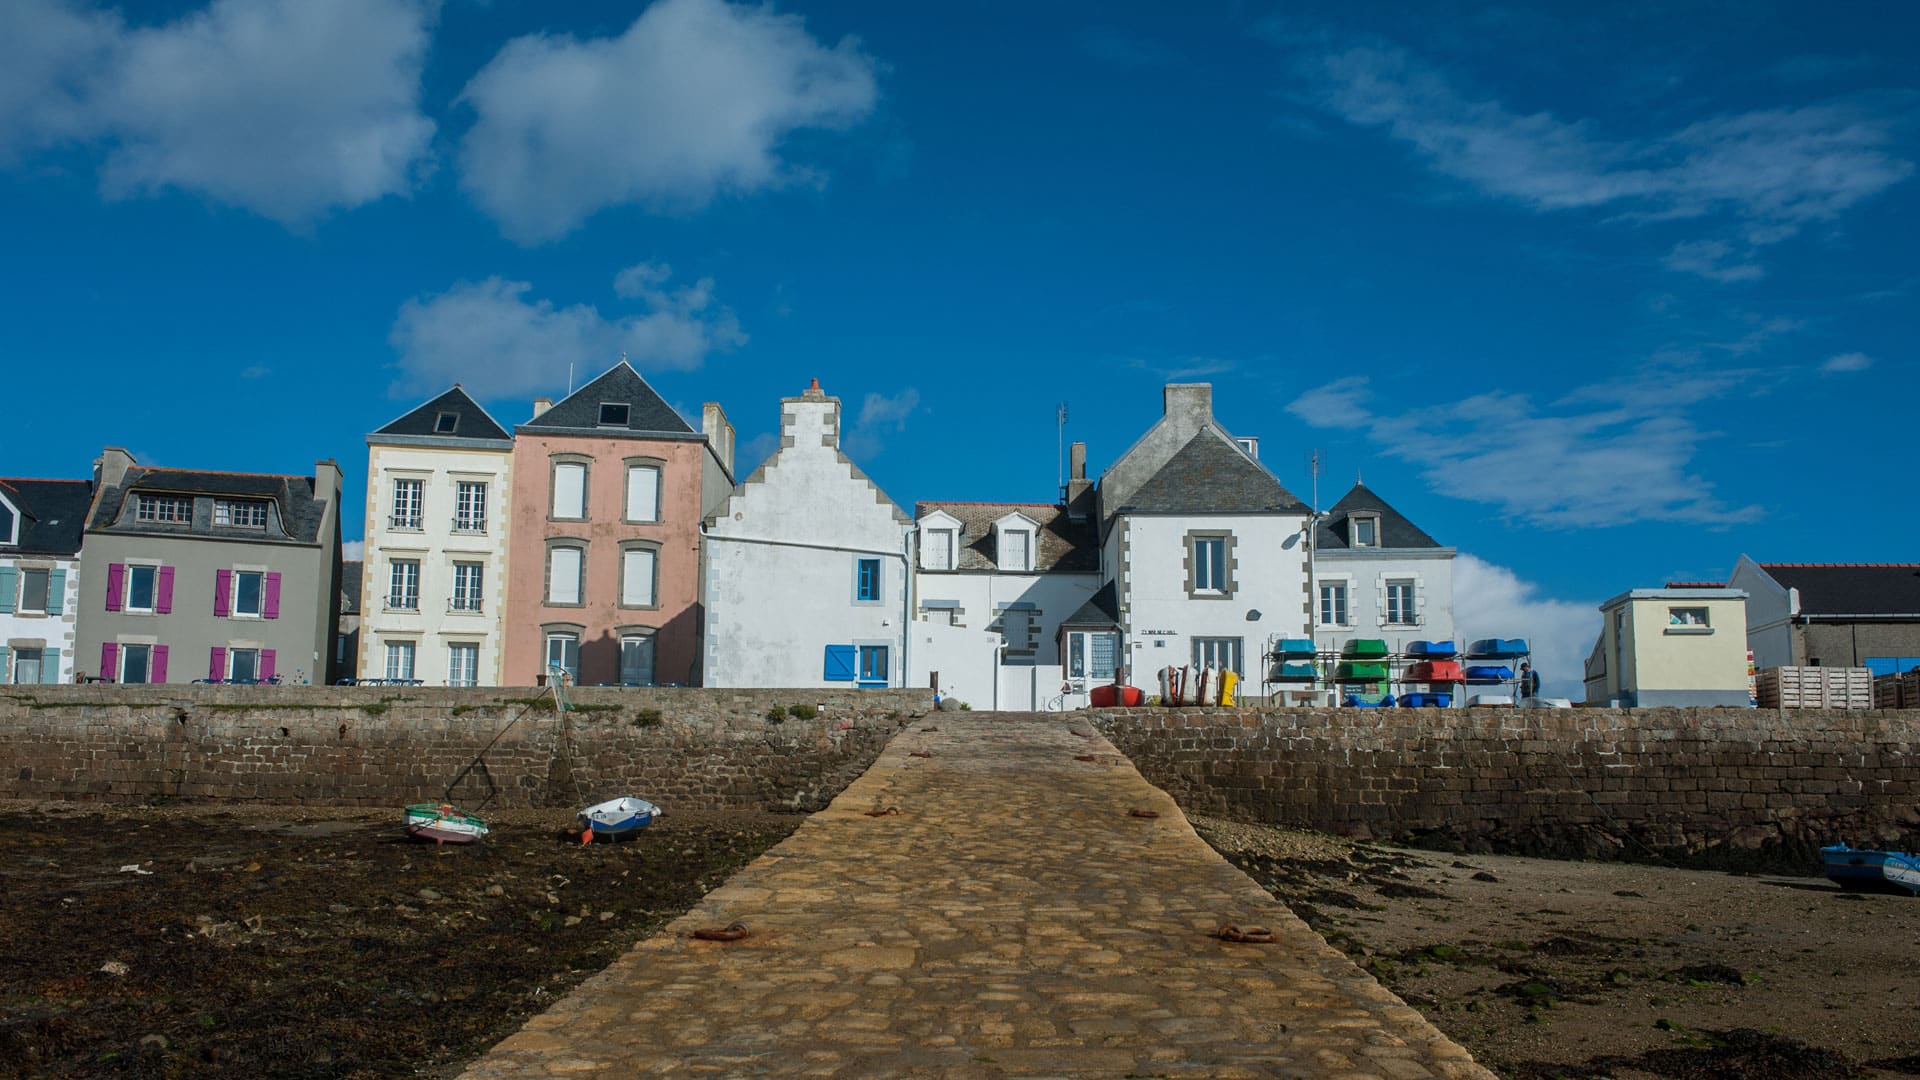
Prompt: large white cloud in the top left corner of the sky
<box><xmin>0</xmin><ymin>0</ymin><xmax>438</xmax><ymax>225</ymax></box>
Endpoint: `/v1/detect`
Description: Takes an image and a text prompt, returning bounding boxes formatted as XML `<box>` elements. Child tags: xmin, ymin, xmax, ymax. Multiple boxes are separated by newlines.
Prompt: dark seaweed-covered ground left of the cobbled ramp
<box><xmin>0</xmin><ymin>803</ymin><xmax>803</xmax><ymax>1078</ymax></box>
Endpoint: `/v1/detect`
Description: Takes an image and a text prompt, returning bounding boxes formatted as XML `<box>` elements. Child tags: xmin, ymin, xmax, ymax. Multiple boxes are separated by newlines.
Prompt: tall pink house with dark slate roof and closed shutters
<box><xmin>503</xmin><ymin>359</ymin><xmax>733</xmax><ymax>686</ymax></box>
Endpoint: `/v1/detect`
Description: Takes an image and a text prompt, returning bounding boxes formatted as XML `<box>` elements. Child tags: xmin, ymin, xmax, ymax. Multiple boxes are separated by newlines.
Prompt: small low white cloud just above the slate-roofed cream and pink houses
<box><xmin>388</xmin><ymin>263</ymin><xmax>747</xmax><ymax>398</ymax></box>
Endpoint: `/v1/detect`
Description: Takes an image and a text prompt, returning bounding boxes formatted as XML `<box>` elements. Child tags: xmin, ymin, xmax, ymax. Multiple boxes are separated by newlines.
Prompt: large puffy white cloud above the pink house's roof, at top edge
<box><xmin>461</xmin><ymin>0</ymin><xmax>877</xmax><ymax>242</ymax></box>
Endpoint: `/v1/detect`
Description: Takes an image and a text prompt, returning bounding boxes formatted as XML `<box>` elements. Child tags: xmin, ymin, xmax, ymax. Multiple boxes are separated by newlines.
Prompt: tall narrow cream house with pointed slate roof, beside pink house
<box><xmin>353</xmin><ymin>386</ymin><xmax>513</xmax><ymax>686</ymax></box>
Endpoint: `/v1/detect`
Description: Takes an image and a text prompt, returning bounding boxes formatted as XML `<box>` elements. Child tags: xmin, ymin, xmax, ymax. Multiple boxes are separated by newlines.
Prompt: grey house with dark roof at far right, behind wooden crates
<box><xmin>1726</xmin><ymin>555</ymin><xmax>1920</xmax><ymax>675</ymax></box>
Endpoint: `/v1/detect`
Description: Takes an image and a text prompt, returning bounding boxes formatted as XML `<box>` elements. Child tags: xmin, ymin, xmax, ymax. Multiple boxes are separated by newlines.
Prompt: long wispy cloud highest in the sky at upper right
<box><xmin>1302</xmin><ymin>44</ymin><xmax>1914</xmax><ymax>272</ymax></box>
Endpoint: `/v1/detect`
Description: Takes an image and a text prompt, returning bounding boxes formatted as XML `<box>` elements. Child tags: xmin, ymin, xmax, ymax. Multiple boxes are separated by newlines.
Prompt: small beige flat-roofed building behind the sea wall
<box><xmin>1586</xmin><ymin>588</ymin><xmax>1753</xmax><ymax>707</ymax></box>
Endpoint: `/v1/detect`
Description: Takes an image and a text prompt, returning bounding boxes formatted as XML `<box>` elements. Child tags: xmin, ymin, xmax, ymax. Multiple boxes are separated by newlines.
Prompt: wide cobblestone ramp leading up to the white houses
<box><xmin>456</xmin><ymin>713</ymin><xmax>1492</xmax><ymax>1080</ymax></box>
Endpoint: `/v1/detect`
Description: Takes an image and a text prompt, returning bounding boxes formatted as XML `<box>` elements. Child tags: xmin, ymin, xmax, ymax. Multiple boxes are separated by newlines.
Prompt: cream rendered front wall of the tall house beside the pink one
<box><xmin>359</xmin><ymin>444</ymin><xmax>510</xmax><ymax>686</ymax></box>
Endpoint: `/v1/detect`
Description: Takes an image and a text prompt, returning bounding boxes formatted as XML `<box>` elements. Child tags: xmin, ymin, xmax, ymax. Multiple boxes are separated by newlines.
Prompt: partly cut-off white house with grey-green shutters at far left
<box><xmin>0</xmin><ymin>479</ymin><xmax>92</xmax><ymax>684</ymax></box>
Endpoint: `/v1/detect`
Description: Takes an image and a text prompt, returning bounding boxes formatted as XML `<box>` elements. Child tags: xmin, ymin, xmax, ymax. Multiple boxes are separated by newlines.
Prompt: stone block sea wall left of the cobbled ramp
<box><xmin>0</xmin><ymin>686</ymin><xmax>933</xmax><ymax>811</ymax></box>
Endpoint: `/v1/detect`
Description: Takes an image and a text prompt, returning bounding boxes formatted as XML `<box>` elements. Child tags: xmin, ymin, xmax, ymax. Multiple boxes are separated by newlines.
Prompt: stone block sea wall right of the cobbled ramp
<box><xmin>1089</xmin><ymin>709</ymin><xmax>1920</xmax><ymax>872</ymax></box>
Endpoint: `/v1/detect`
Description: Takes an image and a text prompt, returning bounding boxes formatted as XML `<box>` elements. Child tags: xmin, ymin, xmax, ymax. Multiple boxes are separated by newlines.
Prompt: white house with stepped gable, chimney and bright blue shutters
<box><xmin>703</xmin><ymin>380</ymin><xmax>912</xmax><ymax>686</ymax></box>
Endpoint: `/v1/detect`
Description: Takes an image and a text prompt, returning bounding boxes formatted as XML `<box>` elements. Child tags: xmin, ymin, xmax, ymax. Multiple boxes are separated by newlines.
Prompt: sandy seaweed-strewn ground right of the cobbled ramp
<box><xmin>1194</xmin><ymin>817</ymin><xmax>1920</xmax><ymax>1080</ymax></box>
